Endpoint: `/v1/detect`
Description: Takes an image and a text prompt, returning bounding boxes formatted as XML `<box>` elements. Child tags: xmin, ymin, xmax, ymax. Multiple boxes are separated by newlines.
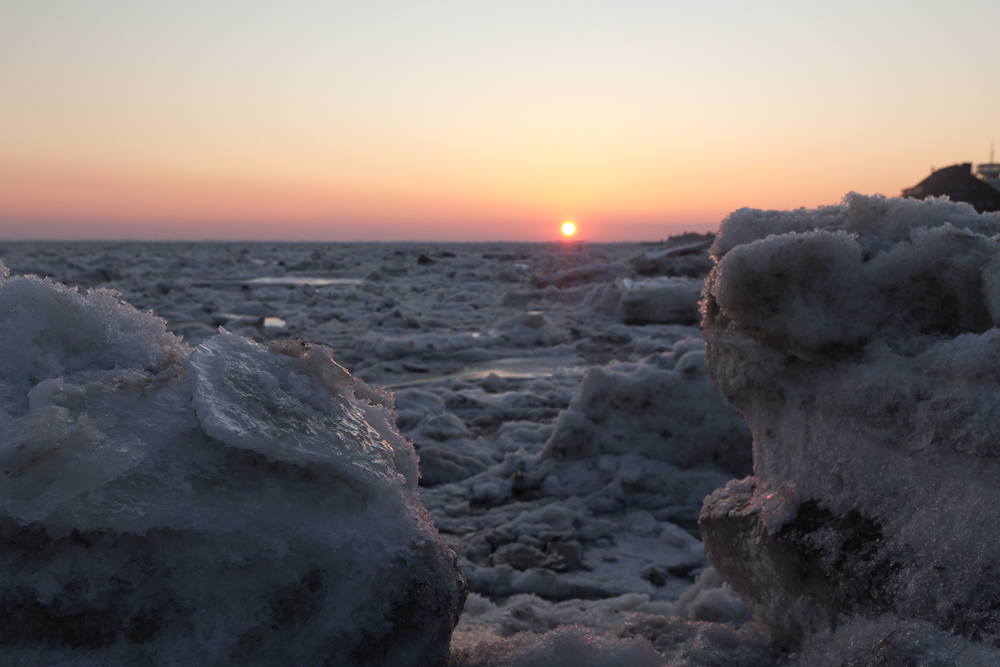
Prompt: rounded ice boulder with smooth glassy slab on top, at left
<box><xmin>0</xmin><ymin>271</ymin><xmax>466</xmax><ymax>666</ymax></box>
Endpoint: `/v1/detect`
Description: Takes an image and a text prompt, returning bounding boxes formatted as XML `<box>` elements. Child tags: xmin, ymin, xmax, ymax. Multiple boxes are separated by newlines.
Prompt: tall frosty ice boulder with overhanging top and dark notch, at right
<box><xmin>701</xmin><ymin>194</ymin><xmax>1000</xmax><ymax>665</ymax></box>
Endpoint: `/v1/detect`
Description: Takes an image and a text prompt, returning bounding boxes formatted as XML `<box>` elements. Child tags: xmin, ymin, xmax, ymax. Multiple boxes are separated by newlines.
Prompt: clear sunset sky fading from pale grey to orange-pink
<box><xmin>0</xmin><ymin>0</ymin><xmax>1000</xmax><ymax>241</ymax></box>
